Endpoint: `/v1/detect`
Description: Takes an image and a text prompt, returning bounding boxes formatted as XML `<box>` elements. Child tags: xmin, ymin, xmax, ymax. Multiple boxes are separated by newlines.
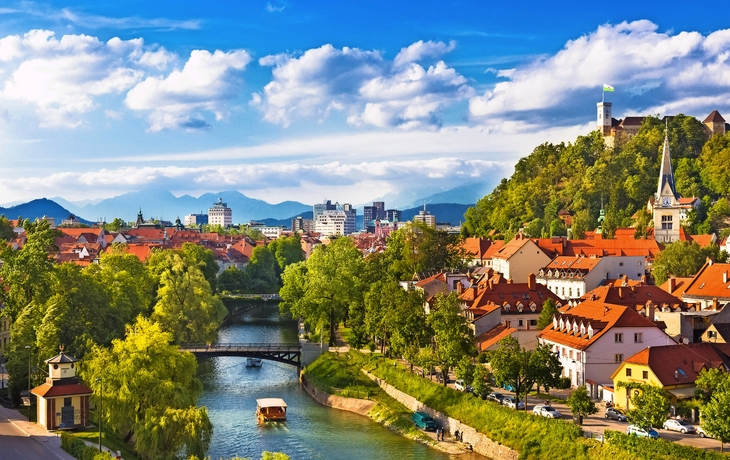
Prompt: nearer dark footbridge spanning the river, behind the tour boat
<box><xmin>180</xmin><ymin>343</ymin><xmax>302</xmax><ymax>367</ymax></box>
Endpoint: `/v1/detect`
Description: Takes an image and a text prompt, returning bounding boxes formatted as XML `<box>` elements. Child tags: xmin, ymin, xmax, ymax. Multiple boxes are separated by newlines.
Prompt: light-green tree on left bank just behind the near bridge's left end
<box><xmin>152</xmin><ymin>252</ymin><xmax>227</xmax><ymax>343</ymax></box>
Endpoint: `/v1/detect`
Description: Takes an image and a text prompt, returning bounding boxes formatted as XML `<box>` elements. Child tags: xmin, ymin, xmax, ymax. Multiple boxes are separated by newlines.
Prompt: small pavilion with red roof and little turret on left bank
<box><xmin>30</xmin><ymin>348</ymin><xmax>92</xmax><ymax>430</ymax></box>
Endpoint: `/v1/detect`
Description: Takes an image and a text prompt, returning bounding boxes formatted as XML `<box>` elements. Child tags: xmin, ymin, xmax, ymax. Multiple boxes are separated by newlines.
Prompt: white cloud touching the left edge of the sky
<box><xmin>0</xmin><ymin>30</ymin><xmax>169</xmax><ymax>127</ymax></box>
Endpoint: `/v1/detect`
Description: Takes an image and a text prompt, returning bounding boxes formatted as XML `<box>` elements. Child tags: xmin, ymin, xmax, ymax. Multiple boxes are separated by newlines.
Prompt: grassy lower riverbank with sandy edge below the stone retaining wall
<box><xmin>300</xmin><ymin>353</ymin><xmax>485</xmax><ymax>459</ymax></box>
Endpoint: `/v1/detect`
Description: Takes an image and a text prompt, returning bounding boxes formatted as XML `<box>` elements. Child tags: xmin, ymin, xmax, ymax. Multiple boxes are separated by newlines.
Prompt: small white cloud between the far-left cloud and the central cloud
<box><xmin>124</xmin><ymin>50</ymin><xmax>251</xmax><ymax>132</ymax></box>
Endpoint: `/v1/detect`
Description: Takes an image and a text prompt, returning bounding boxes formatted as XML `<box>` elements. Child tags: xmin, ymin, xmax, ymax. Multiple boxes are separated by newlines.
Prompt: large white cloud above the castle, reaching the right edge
<box><xmin>469</xmin><ymin>20</ymin><xmax>730</xmax><ymax>119</ymax></box>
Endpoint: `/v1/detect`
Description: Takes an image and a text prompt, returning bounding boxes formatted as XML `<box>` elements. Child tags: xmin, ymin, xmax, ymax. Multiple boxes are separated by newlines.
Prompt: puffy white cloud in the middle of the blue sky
<box><xmin>251</xmin><ymin>41</ymin><xmax>472</xmax><ymax>128</ymax></box>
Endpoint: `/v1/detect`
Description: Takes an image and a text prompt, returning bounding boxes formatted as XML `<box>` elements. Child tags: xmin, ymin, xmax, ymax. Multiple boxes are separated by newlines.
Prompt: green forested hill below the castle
<box><xmin>462</xmin><ymin>115</ymin><xmax>730</xmax><ymax>238</ymax></box>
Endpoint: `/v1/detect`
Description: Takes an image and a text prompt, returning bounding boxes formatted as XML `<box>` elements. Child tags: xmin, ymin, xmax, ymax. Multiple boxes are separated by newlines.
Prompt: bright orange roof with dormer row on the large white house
<box><xmin>539</xmin><ymin>301</ymin><xmax>657</xmax><ymax>350</ymax></box>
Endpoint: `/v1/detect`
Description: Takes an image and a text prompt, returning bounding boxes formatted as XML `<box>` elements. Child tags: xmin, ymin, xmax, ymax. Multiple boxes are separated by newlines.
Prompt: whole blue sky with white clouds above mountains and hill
<box><xmin>0</xmin><ymin>0</ymin><xmax>730</xmax><ymax>204</ymax></box>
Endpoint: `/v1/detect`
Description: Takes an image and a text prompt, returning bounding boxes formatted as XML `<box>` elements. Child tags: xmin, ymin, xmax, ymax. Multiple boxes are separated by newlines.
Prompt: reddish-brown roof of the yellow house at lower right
<box><xmin>625</xmin><ymin>343</ymin><xmax>730</xmax><ymax>386</ymax></box>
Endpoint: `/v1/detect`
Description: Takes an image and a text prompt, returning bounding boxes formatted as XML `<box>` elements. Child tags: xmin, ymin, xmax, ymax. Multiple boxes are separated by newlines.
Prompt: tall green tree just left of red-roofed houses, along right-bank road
<box><xmin>427</xmin><ymin>292</ymin><xmax>477</xmax><ymax>385</ymax></box>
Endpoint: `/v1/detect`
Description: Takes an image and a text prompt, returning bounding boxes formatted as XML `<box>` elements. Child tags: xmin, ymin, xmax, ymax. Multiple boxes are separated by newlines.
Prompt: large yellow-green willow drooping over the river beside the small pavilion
<box><xmin>82</xmin><ymin>316</ymin><xmax>213</xmax><ymax>458</ymax></box>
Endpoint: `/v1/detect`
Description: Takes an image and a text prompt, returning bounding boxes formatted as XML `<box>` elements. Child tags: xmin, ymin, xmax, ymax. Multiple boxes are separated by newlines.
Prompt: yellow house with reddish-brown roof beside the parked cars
<box><xmin>611</xmin><ymin>343</ymin><xmax>730</xmax><ymax>410</ymax></box>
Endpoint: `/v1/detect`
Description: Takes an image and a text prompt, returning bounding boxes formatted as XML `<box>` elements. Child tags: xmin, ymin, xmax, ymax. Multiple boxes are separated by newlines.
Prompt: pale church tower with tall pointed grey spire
<box><xmin>654</xmin><ymin>124</ymin><xmax>680</xmax><ymax>243</ymax></box>
